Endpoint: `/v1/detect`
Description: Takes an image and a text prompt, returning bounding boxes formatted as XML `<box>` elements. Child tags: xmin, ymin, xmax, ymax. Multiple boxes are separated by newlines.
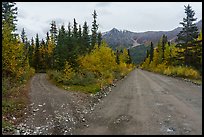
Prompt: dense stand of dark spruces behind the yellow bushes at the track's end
<box><xmin>21</xmin><ymin>11</ymin><xmax>102</xmax><ymax>72</ymax></box>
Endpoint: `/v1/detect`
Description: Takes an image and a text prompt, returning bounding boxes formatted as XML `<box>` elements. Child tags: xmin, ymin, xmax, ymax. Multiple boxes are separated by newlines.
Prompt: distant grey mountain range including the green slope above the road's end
<box><xmin>102</xmin><ymin>20</ymin><xmax>202</xmax><ymax>64</ymax></box>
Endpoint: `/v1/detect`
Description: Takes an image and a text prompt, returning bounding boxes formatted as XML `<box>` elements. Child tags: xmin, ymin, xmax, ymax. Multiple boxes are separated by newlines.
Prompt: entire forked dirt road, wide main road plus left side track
<box><xmin>15</xmin><ymin>69</ymin><xmax>202</xmax><ymax>134</ymax></box>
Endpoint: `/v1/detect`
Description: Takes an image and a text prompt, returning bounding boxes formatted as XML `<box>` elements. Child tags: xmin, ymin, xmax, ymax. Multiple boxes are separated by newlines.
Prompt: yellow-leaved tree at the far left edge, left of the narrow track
<box><xmin>2</xmin><ymin>21</ymin><xmax>29</xmax><ymax>79</ymax></box>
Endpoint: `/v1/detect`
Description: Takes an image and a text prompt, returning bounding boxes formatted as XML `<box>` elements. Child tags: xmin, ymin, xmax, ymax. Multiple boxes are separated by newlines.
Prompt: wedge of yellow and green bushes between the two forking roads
<box><xmin>47</xmin><ymin>41</ymin><xmax>134</xmax><ymax>93</ymax></box>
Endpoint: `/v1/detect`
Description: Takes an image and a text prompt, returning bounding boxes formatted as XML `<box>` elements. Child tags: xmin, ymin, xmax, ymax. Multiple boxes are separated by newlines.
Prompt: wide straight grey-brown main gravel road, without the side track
<box><xmin>74</xmin><ymin>69</ymin><xmax>202</xmax><ymax>135</ymax></box>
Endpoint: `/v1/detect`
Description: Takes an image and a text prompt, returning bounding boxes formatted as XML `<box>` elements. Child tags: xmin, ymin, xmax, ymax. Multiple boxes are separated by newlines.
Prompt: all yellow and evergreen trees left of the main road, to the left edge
<box><xmin>2</xmin><ymin>2</ymin><xmax>133</xmax><ymax>94</ymax></box>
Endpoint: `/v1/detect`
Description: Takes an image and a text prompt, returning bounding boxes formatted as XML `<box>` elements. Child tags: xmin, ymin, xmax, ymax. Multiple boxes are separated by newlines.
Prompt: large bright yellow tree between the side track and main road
<box><xmin>78</xmin><ymin>41</ymin><xmax>117</xmax><ymax>86</ymax></box>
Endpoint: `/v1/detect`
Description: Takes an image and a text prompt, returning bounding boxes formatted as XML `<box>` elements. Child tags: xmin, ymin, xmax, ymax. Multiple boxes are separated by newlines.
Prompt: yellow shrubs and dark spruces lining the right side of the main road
<box><xmin>141</xmin><ymin>5</ymin><xmax>202</xmax><ymax>79</ymax></box>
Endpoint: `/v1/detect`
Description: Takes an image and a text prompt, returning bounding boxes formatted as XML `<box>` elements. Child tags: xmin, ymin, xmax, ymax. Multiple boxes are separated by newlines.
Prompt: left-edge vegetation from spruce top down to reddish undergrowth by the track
<box><xmin>2</xmin><ymin>2</ymin><xmax>35</xmax><ymax>130</ymax></box>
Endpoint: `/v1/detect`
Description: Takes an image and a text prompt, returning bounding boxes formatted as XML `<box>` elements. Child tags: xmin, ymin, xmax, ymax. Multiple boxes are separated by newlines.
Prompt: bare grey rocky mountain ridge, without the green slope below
<box><xmin>102</xmin><ymin>20</ymin><xmax>202</xmax><ymax>49</ymax></box>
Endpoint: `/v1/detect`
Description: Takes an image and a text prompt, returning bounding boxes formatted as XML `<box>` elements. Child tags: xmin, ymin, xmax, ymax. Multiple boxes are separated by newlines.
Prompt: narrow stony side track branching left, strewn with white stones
<box><xmin>2</xmin><ymin>73</ymin><xmax>110</xmax><ymax>135</ymax></box>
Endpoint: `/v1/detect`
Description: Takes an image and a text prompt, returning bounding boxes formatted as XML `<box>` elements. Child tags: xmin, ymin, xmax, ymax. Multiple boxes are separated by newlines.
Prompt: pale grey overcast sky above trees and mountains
<box><xmin>16</xmin><ymin>2</ymin><xmax>202</xmax><ymax>39</ymax></box>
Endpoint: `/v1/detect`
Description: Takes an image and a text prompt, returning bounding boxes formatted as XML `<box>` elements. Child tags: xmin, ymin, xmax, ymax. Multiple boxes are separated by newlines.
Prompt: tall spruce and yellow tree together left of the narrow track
<box><xmin>2</xmin><ymin>2</ymin><xmax>34</xmax><ymax>91</ymax></box>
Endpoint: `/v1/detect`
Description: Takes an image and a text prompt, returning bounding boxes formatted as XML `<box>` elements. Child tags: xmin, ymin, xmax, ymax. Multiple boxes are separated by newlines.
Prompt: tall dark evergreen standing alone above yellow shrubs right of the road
<box><xmin>176</xmin><ymin>5</ymin><xmax>198</xmax><ymax>66</ymax></box>
